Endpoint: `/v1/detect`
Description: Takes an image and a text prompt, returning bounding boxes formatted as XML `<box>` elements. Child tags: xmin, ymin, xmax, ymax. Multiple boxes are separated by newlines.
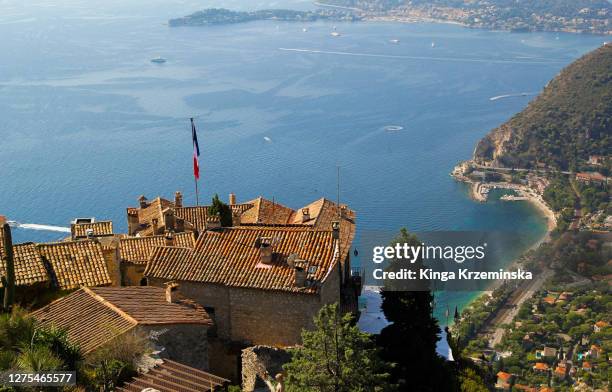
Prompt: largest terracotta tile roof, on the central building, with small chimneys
<box><xmin>145</xmin><ymin>226</ymin><xmax>339</xmax><ymax>293</ymax></box>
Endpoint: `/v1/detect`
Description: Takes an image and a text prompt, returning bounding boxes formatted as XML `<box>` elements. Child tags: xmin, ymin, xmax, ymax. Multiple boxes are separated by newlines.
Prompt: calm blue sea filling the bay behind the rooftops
<box><xmin>0</xmin><ymin>0</ymin><xmax>604</xmax><ymax>350</ymax></box>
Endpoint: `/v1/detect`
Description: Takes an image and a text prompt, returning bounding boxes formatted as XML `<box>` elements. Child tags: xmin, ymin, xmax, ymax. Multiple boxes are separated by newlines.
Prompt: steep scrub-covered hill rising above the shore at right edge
<box><xmin>474</xmin><ymin>44</ymin><xmax>612</xmax><ymax>169</ymax></box>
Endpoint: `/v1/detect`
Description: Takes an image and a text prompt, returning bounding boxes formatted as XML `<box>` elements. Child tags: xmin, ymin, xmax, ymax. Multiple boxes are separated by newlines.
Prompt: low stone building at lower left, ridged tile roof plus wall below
<box><xmin>31</xmin><ymin>285</ymin><xmax>212</xmax><ymax>370</ymax></box>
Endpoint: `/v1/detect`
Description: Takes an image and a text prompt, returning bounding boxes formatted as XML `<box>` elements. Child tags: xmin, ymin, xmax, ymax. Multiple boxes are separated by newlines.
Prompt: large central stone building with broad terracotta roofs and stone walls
<box><xmin>144</xmin><ymin>198</ymin><xmax>361</xmax><ymax>380</ymax></box>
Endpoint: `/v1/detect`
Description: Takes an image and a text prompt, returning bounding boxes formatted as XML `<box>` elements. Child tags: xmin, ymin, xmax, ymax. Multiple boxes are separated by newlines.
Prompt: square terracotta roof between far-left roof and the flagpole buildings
<box><xmin>37</xmin><ymin>241</ymin><xmax>111</xmax><ymax>290</ymax></box>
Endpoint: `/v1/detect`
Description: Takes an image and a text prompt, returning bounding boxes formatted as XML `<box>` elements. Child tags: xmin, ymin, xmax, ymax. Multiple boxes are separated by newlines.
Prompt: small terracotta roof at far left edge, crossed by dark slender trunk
<box><xmin>0</xmin><ymin>239</ymin><xmax>49</xmax><ymax>287</ymax></box>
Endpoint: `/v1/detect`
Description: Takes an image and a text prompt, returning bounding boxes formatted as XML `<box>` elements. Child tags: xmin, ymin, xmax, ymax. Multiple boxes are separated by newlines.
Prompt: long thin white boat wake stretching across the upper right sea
<box><xmin>278</xmin><ymin>48</ymin><xmax>562</xmax><ymax>65</ymax></box>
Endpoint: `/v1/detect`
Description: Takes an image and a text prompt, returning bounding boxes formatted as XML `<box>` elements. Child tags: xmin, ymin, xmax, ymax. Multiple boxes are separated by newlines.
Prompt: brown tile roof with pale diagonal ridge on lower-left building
<box><xmin>32</xmin><ymin>286</ymin><xmax>212</xmax><ymax>353</ymax></box>
